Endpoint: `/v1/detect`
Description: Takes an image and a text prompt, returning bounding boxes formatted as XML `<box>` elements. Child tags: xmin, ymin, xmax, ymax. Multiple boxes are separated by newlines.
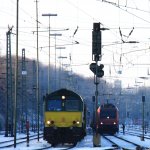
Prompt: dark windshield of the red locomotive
<box><xmin>100</xmin><ymin>109</ymin><xmax>116</xmax><ymax>119</ymax></box>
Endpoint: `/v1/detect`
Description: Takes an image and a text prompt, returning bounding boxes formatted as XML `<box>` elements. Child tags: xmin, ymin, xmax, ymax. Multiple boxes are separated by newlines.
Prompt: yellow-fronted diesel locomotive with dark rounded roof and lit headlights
<box><xmin>44</xmin><ymin>89</ymin><xmax>86</xmax><ymax>146</ymax></box>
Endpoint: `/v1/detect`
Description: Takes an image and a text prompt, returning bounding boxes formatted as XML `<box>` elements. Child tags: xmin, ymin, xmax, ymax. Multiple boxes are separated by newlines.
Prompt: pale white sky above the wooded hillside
<box><xmin>0</xmin><ymin>0</ymin><xmax>150</xmax><ymax>87</ymax></box>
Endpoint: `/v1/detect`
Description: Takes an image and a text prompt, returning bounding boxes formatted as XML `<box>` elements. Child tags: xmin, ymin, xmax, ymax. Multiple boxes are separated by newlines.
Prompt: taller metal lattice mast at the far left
<box><xmin>5</xmin><ymin>28</ymin><xmax>13</xmax><ymax>137</ymax></box>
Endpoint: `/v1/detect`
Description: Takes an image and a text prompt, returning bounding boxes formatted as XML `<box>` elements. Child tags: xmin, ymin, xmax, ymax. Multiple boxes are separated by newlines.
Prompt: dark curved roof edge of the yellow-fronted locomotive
<box><xmin>47</xmin><ymin>89</ymin><xmax>82</xmax><ymax>99</ymax></box>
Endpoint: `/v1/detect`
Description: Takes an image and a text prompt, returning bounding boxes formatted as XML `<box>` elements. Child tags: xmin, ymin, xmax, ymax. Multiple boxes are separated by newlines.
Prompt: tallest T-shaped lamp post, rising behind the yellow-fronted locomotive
<box><xmin>42</xmin><ymin>13</ymin><xmax>57</xmax><ymax>93</ymax></box>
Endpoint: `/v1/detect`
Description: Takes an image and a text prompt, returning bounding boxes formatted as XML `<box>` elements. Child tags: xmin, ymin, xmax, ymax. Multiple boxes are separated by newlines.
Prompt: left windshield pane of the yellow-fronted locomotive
<box><xmin>46</xmin><ymin>100</ymin><xmax>62</xmax><ymax>111</ymax></box>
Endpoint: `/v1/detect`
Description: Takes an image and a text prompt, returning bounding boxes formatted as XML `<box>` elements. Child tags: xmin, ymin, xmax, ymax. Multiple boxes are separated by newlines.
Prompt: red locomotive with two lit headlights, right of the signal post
<box><xmin>97</xmin><ymin>103</ymin><xmax>119</xmax><ymax>134</ymax></box>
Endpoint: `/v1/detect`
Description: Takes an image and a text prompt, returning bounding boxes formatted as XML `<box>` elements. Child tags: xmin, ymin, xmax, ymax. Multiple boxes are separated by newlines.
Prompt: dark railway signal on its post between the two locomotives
<box><xmin>90</xmin><ymin>23</ymin><xmax>104</xmax><ymax>147</ymax></box>
